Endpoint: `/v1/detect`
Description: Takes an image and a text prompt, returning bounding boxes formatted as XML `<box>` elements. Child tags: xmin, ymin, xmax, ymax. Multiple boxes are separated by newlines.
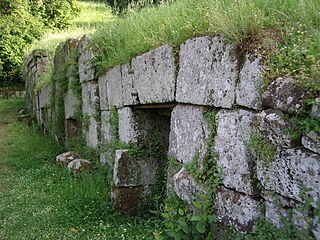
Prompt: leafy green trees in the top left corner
<box><xmin>0</xmin><ymin>0</ymin><xmax>80</xmax><ymax>87</ymax></box>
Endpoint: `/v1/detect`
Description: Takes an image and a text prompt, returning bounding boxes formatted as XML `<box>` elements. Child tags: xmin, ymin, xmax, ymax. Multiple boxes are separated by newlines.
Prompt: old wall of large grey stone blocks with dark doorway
<box><xmin>27</xmin><ymin>36</ymin><xmax>320</xmax><ymax>239</ymax></box>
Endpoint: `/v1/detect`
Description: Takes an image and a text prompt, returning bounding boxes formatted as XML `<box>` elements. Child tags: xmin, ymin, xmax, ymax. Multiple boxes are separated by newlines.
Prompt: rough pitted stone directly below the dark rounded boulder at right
<box><xmin>254</xmin><ymin>109</ymin><xmax>297</xmax><ymax>147</ymax></box>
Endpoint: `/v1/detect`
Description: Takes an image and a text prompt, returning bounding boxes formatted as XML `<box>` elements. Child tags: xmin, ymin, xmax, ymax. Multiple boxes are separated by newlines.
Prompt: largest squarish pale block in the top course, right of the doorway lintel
<box><xmin>176</xmin><ymin>36</ymin><xmax>238</xmax><ymax>108</ymax></box>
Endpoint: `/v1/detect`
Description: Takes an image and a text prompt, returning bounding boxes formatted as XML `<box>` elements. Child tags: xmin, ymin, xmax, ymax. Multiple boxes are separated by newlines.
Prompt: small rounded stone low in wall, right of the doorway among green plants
<box><xmin>173</xmin><ymin>168</ymin><xmax>203</xmax><ymax>204</ymax></box>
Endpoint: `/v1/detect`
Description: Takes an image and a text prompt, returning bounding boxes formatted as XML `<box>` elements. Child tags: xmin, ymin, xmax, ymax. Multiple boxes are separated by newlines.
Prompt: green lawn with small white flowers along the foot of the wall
<box><xmin>0</xmin><ymin>100</ymin><xmax>158</xmax><ymax>240</ymax></box>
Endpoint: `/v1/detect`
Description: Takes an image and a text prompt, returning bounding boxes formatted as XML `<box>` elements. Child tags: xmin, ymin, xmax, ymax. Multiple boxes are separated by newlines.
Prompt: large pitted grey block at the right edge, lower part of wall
<box><xmin>257</xmin><ymin>148</ymin><xmax>320</xmax><ymax>207</ymax></box>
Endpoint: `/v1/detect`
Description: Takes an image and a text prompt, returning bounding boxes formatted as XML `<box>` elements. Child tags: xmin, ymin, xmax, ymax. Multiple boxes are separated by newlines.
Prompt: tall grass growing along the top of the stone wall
<box><xmin>93</xmin><ymin>0</ymin><xmax>320</xmax><ymax>91</ymax></box>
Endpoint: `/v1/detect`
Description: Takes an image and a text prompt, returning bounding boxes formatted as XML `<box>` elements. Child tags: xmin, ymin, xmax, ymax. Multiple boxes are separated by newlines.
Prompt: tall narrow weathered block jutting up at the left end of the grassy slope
<box><xmin>78</xmin><ymin>35</ymin><xmax>95</xmax><ymax>83</ymax></box>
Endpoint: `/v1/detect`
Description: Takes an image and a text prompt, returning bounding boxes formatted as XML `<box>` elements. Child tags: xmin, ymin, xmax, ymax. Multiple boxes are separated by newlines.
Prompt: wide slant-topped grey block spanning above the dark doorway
<box><xmin>130</xmin><ymin>45</ymin><xmax>176</xmax><ymax>104</ymax></box>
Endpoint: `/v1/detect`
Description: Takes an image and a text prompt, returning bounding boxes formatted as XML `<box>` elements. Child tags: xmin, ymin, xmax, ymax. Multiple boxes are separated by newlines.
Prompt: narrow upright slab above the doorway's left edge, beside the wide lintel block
<box><xmin>121</xmin><ymin>64</ymin><xmax>139</xmax><ymax>106</ymax></box>
